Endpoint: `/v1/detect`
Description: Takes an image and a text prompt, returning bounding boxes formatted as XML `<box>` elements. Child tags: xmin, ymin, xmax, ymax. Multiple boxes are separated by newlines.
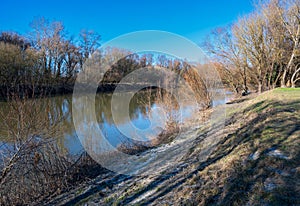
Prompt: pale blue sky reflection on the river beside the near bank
<box><xmin>64</xmin><ymin>92</ymin><xmax>232</xmax><ymax>154</ymax></box>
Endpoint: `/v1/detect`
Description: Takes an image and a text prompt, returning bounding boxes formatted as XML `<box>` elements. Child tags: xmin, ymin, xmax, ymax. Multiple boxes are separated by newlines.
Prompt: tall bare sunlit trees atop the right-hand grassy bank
<box><xmin>206</xmin><ymin>0</ymin><xmax>300</xmax><ymax>94</ymax></box>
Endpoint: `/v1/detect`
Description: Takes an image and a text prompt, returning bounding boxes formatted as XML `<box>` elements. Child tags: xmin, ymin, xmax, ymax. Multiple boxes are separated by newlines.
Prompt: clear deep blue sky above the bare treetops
<box><xmin>0</xmin><ymin>0</ymin><xmax>253</xmax><ymax>43</ymax></box>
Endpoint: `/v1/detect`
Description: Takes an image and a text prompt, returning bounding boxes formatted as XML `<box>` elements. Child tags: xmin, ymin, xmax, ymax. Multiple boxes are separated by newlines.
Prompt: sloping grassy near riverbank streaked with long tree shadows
<box><xmin>42</xmin><ymin>89</ymin><xmax>300</xmax><ymax>205</ymax></box>
